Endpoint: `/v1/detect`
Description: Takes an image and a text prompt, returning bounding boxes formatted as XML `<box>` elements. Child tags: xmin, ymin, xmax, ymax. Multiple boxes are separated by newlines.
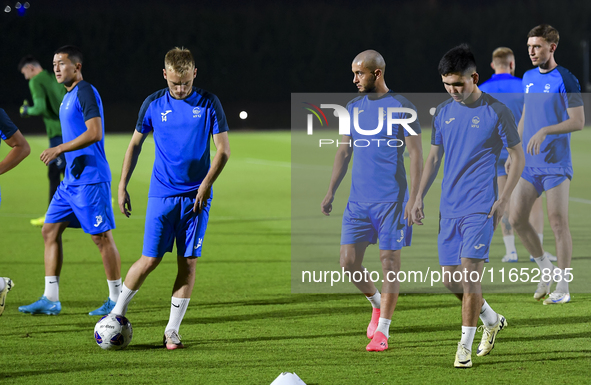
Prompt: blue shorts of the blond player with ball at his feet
<box><xmin>142</xmin><ymin>197</ymin><xmax>211</xmax><ymax>258</ymax></box>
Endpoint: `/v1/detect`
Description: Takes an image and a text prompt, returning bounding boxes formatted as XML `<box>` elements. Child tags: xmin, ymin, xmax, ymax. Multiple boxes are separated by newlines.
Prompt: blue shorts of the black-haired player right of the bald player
<box><xmin>437</xmin><ymin>214</ymin><xmax>494</xmax><ymax>266</ymax></box>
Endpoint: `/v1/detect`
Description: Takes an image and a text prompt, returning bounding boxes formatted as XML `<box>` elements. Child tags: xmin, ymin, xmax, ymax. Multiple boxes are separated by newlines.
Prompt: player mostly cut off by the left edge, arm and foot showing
<box><xmin>0</xmin><ymin>108</ymin><xmax>31</xmax><ymax>315</ymax></box>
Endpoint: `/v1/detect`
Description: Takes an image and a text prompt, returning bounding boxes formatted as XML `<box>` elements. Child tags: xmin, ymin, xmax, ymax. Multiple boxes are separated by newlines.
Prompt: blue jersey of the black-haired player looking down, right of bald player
<box><xmin>431</xmin><ymin>92</ymin><xmax>519</xmax><ymax>218</ymax></box>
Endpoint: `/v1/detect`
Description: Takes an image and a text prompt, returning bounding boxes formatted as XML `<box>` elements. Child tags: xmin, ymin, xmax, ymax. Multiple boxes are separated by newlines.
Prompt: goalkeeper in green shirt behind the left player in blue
<box><xmin>18</xmin><ymin>55</ymin><xmax>66</xmax><ymax>226</ymax></box>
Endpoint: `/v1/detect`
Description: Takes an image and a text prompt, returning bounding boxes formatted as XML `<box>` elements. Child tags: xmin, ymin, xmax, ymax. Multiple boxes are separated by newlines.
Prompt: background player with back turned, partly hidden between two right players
<box><xmin>478</xmin><ymin>47</ymin><xmax>556</xmax><ymax>262</ymax></box>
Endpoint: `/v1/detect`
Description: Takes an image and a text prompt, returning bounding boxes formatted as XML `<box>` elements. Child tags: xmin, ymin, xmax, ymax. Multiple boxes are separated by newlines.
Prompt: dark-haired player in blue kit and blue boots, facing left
<box><xmin>18</xmin><ymin>46</ymin><xmax>121</xmax><ymax>315</ymax></box>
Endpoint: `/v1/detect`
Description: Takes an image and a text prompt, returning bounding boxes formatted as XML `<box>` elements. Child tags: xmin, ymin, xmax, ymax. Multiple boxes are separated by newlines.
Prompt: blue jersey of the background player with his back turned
<box><xmin>478</xmin><ymin>74</ymin><xmax>523</xmax><ymax>159</ymax></box>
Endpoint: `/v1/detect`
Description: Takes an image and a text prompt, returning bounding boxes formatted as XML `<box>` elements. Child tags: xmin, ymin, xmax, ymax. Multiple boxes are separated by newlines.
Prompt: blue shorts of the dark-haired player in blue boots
<box><xmin>45</xmin><ymin>182</ymin><xmax>115</xmax><ymax>234</ymax></box>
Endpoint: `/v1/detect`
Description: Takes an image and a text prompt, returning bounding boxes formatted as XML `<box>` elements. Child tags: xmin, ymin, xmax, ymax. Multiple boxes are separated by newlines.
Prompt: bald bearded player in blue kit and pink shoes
<box><xmin>321</xmin><ymin>50</ymin><xmax>423</xmax><ymax>351</ymax></box>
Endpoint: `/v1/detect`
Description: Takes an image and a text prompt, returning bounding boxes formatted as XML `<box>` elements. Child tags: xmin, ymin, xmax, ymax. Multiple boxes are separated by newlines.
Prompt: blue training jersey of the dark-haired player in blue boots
<box><xmin>60</xmin><ymin>80</ymin><xmax>111</xmax><ymax>186</ymax></box>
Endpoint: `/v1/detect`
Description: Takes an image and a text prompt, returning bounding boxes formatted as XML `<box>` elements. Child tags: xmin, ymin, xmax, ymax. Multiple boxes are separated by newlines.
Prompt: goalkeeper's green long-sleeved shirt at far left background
<box><xmin>27</xmin><ymin>70</ymin><xmax>66</xmax><ymax>138</ymax></box>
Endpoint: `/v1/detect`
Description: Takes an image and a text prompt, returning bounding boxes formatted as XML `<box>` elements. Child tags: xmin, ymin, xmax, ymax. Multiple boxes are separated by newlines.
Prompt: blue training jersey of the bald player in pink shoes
<box><xmin>347</xmin><ymin>91</ymin><xmax>421</xmax><ymax>202</ymax></box>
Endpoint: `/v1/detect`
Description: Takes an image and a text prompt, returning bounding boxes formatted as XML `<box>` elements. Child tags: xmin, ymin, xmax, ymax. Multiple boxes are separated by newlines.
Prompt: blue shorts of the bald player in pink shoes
<box><xmin>341</xmin><ymin>202</ymin><xmax>412</xmax><ymax>250</ymax></box>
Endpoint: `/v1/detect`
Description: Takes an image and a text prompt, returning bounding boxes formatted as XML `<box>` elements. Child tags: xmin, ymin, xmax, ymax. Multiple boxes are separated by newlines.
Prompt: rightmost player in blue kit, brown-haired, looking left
<box><xmin>508</xmin><ymin>24</ymin><xmax>585</xmax><ymax>305</ymax></box>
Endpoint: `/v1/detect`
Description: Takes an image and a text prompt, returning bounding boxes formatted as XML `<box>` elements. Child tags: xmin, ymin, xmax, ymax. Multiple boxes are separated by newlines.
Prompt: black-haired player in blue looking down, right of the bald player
<box><xmin>412</xmin><ymin>45</ymin><xmax>524</xmax><ymax>368</ymax></box>
